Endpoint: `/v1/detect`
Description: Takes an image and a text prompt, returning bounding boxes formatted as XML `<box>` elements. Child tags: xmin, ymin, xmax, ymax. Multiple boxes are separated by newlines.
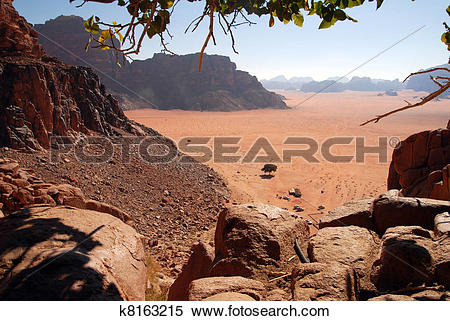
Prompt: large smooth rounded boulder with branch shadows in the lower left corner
<box><xmin>0</xmin><ymin>206</ymin><xmax>147</xmax><ymax>300</ymax></box>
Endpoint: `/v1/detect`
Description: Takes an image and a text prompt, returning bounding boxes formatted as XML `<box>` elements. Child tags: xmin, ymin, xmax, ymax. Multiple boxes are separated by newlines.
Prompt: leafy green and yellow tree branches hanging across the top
<box><xmin>69</xmin><ymin>0</ymin><xmax>392</xmax><ymax>64</ymax></box>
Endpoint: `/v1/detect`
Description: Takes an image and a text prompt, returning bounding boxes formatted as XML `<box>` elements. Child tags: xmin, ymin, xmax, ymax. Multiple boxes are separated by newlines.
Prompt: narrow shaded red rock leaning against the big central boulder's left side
<box><xmin>167</xmin><ymin>242</ymin><xmax>214</xmax><ymax>301</ymax></box>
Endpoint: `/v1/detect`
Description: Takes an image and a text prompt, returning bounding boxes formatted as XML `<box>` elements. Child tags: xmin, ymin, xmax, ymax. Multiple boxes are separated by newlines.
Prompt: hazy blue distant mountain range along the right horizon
<box><xmin>261</xmin><ymin>64</ymin><xmax>450</xmax><ymax>96</ymax></box>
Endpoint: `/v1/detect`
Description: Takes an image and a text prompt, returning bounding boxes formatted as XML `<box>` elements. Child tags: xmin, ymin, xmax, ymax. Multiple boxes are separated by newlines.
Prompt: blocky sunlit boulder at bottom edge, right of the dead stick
<box><xmin>291</xmin><ymin>263</ymin><xmax>358</xmax><ymax>301</ymax></box>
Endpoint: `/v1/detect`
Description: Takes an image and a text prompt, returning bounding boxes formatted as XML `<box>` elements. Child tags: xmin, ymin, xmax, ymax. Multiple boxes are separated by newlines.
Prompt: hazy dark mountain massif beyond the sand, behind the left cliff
<box><xmin>35</xmin><ymin>16</ymin><xmax>287</xmax><ymax>111</ymax></box>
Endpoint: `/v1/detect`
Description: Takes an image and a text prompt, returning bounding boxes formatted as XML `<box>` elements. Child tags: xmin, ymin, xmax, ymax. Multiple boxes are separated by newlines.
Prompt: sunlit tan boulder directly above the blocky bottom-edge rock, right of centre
<box><xmin>308</xmin><ymin>226</ymin><xmax>380</xmax><ymax>292</ymax></box>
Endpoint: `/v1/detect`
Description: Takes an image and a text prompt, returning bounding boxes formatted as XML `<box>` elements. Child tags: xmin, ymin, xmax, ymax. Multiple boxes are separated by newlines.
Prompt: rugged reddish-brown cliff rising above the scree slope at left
<box><xmin>0</xmin><ymin>1</ymin><xmax>150</xmax><ymax>150</ymax></box>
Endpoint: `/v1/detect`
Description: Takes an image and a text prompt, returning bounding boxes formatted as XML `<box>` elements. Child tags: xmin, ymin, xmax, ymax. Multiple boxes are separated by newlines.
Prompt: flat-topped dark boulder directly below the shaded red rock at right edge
<box><xmin>372</xmin><ymin>195</ymin><xmax>450</xmax><ymax>235</ymax></box>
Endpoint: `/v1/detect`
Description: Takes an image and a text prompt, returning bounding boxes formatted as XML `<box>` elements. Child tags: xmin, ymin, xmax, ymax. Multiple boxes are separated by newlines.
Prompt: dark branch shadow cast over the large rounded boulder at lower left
<box><xmin>0</xmin><ymin>209</ymin><xmax>122</xmax><ymax>300</ymax></box>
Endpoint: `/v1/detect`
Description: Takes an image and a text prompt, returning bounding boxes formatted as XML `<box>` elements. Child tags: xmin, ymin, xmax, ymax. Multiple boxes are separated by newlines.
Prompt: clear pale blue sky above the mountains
<box><xmin>14</xmin><ymin>0</ymin><xmax>450</xmax><ymax>80</ymax></box>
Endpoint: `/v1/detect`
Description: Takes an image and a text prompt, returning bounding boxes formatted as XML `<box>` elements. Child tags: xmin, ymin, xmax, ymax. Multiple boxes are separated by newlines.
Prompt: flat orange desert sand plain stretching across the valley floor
<box><xmin>126</xmin><ymin>91</ymin><xmax>450</xmax><ymax>226</ymax></box>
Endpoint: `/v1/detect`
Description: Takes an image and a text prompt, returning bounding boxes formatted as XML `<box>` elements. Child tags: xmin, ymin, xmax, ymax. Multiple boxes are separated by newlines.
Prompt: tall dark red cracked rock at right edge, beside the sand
<box><xmin>387</xmin><ymin>128</ymin><xmax>450</xmax><ymax>200</ymax></box>
